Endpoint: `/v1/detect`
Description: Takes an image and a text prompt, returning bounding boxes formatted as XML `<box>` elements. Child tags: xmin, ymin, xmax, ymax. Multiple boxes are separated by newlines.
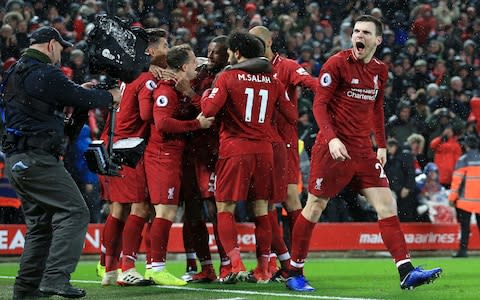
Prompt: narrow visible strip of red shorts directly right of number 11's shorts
<box><xmin>270</xmin><ymin>143</ymin><xmax>288</xmax><ymax>203</ymax></box>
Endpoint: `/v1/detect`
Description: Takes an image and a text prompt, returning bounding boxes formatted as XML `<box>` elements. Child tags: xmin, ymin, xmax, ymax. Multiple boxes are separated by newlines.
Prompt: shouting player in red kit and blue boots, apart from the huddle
<box><xmin>287</xmin><ymin>15</ymin><xmax>442</xmax><ymax>291</ymax></box>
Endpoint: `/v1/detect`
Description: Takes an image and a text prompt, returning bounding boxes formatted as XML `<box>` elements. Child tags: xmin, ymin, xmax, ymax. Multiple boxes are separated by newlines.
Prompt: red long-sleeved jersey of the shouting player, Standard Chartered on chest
<box><xmin>313</xmin><ymin>49</ymin><xmax>388</xmax><ymax>154</ymax></box>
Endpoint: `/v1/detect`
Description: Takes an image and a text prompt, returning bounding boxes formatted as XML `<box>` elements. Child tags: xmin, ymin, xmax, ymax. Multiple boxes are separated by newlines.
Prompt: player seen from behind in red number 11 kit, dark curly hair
<box><xmin>202</xmin><ymin>32</ymin><xmax>296</xmax><ymax>283</ymax></box>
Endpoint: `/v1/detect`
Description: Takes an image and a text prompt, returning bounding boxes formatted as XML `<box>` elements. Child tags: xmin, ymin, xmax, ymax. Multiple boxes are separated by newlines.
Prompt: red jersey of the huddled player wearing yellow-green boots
<box><xmin>147</xmin><ymin>81</ymin><xmax>200</xmax><ymax>154</ymax></box>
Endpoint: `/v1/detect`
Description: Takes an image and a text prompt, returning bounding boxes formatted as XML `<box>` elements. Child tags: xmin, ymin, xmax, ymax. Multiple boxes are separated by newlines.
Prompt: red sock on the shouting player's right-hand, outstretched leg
<box><xmin>378</xmin><ymin>216</ymin><xmax>413</xmax><ymax>280</ymax></box>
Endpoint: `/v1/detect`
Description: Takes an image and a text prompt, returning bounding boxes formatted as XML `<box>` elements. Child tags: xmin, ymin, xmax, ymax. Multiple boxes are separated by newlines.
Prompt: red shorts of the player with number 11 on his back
<box><xmin>215</xmin><ymin>153</ymin><xmax>273</xmax><ymax>202</ymax></box>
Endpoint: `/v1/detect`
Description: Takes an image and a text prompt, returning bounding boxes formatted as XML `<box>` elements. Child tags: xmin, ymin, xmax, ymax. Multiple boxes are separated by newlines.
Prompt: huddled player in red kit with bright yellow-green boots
<box><xmin>145</xmin><ymin>45</ymin><xmax>214</xmax><ymax>286</ymax></box>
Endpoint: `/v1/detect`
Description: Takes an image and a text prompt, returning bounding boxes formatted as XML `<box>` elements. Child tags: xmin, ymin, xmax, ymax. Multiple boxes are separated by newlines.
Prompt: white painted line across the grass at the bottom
<box><xmin>0</xmin><ymin>276</ymin><xmax>381</xmax><ymax>300</ymax></box>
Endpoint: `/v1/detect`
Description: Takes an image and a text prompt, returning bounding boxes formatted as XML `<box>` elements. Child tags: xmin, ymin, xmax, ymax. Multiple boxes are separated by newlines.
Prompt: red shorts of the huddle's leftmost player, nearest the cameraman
<box><xmin>108</xmin><ymin>158</ymin><xmax>148</xmax><ymax>203</ymax></box>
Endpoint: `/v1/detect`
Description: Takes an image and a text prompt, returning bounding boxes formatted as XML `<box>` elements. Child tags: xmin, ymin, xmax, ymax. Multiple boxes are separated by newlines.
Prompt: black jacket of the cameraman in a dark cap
<box><xmin>5</xmin><ymin>49</ymin><xmax>113</xmax><ymax>136</ymax></box>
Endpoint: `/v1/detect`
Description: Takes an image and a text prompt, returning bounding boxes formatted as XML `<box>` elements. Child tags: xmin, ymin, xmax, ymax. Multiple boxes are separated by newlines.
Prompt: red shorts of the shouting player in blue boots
<box><xmin>308</xmin><ymin>144</ymin><xmax>389</xmax><ymax>198</ymax></box>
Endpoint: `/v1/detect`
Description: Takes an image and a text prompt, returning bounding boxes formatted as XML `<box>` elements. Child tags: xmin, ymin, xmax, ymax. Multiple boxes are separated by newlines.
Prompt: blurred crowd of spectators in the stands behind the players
<box><xmin>0</xmin><ymin>0</ymin><xmax>480</xmax><ymax>222</ymax></box>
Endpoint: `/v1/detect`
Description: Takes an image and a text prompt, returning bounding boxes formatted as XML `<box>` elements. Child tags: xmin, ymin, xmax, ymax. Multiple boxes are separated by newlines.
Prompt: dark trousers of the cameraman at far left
<box><xmin>5</xmin><ymin>150</ymin><xmax>90</xmax><ymax>292</ymax></box>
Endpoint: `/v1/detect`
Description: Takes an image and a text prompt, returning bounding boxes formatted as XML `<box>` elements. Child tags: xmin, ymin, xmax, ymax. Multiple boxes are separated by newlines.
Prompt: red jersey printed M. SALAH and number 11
<box><xmin>201</xmin><ymin>70</ymin><xmax>297</xmax><ymax>158</ymax></box>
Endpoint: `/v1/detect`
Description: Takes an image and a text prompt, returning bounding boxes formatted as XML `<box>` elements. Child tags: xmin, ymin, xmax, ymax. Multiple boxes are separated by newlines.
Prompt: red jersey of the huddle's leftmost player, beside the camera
<box><xmin>114</xmin><ymin>72</ymin><xmax>155</xmax><ymax>140</ymax></box>
